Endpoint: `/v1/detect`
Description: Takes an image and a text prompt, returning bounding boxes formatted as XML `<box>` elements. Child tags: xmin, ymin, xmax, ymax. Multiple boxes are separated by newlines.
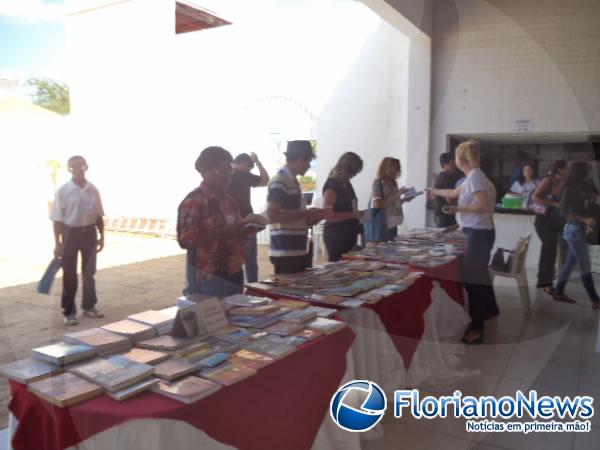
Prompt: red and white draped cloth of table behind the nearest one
<box><xmin>247</xmin><ymin>259</ymin><xmax>470</xmax><ymax>391</ymax></box>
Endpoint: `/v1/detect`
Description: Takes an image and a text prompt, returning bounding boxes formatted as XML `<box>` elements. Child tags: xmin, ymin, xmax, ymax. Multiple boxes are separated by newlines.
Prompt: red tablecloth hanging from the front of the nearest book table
<box><xmin>9</xmin><ymin>328</ymin><xmax>354</xmax><ymax>450</ymax></box>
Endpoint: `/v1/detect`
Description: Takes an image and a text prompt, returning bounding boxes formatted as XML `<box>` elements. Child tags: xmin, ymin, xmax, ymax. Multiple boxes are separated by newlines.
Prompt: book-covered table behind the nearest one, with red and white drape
<box><xmin>247</xmin><ymin>230</ymin><xmax>469</xmax><ymax>388</ymax></box>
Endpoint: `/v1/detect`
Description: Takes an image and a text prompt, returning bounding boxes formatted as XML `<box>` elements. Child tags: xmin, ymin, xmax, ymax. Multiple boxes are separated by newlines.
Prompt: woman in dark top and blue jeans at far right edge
<box><xmin>551</xmin><ymin>161</ymin><xmax>600</xmax><ymax>309</ymax></box>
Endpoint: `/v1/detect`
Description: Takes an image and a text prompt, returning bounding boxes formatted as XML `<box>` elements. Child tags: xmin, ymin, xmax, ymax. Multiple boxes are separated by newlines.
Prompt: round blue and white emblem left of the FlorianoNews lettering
<box><xmin>329</xmin><ymin>380</ymin><xmax>387</xmax><ymax>432</ymax></box>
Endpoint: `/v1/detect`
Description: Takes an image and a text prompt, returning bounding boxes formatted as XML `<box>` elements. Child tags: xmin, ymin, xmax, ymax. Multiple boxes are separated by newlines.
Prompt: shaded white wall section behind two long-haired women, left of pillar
<box><xmin>317</xmin><ymin>21</ymin><xmax>409</xmax><ymax>208</ymax></box>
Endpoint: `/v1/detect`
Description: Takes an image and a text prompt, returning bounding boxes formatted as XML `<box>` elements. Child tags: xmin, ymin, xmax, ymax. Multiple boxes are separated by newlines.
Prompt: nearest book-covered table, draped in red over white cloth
<box><xmin>0</xmin><ymin>296</ymin><xmax>360</xmax><ymax>450</ymax></box>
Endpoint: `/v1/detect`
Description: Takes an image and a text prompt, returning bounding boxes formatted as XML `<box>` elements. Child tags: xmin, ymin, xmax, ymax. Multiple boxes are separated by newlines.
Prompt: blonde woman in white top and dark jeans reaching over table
<box><xmin>428</xmin><ymin>140</ymin><xmax>499</xmax><ymax>344</ymax></box>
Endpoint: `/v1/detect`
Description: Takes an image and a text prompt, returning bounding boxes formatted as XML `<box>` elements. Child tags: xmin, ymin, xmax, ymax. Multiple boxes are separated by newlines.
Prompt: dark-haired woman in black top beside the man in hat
<box><xmin>323</xmin><ymin>152</ymin><xmax>363</xmax><ymax>261</ymax></box>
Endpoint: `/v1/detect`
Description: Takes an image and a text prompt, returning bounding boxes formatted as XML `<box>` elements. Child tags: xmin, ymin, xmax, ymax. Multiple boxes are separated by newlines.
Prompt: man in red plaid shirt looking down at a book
<box><xmin>177</xmin><ymin>147</ymin><xmax>257</xmax><ymax>297</ymax></box>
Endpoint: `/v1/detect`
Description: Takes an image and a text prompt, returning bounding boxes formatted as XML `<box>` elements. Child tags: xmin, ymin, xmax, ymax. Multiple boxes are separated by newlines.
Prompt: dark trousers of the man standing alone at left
<box><xmin>61</xmin><ymin>225</ymin><xmax>98</xmax><ymax>316</ymax></box>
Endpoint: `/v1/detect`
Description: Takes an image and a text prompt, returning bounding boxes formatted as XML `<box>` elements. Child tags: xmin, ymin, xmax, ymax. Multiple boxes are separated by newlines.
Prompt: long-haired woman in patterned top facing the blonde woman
<box><xmin>371</xmin><ymin>157</ymin><xmax>409</xmax><ymax>242</ymax></box>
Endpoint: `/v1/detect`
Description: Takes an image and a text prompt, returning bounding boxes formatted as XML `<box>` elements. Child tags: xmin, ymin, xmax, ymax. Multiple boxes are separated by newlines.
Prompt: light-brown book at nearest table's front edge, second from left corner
<box><xmin>28</xmin><ymin>372</ymin><xmax>102</xmax><ymax>408</ymax></box>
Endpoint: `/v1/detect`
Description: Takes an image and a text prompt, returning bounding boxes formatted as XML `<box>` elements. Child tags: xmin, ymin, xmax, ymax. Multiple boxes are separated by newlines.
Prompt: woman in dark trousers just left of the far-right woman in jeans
<box><xmin>532</xmin><ymin>161</ymin><xmax>567</xmax><ymax>294</ymax></box>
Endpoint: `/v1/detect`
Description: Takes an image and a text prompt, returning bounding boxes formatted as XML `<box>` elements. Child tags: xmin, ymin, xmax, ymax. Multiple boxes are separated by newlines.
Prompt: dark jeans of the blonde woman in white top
<box><xmin>463</xmin><ymin>228</ymin><xmax>499</xmax><ymax>330</ymax></box>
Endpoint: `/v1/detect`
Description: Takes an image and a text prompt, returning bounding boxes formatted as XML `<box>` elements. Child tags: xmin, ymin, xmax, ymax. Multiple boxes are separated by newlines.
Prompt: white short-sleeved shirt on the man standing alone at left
<box><xmin>50</xmin><ymin>180</ymin><xmax>104</xmax><ymax>227</ymax></box>
